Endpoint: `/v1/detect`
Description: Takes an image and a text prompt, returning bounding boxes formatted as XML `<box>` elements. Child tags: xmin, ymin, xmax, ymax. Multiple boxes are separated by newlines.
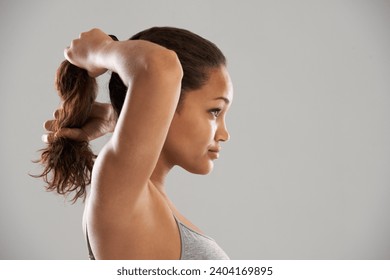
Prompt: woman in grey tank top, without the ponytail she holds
<box><xmin>40</xmin><ymin>27</ymin><xmax>233</xmax><ymax>259</ymax></box>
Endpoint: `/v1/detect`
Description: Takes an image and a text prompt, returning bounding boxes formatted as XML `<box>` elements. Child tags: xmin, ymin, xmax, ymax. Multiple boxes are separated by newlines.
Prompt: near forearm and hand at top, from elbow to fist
<box><xmin>64</xmin><ymin>29</ymin><xmax>183</xmax><ymax>82</ymax></box>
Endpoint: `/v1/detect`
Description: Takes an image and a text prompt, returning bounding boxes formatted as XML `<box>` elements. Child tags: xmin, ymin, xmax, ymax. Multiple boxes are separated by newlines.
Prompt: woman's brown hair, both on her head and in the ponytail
<box><xmin>35</xmin><ymin>27</ymin><xmax>226</xmax><ymax>202</ymax></box>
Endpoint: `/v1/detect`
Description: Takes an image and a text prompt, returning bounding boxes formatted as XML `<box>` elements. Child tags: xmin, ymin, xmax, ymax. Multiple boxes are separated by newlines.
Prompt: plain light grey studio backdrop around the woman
<box><xmin>0</xmin><ymin>0</ymin><xmax>390</xmax><ymax>259</ymax></box>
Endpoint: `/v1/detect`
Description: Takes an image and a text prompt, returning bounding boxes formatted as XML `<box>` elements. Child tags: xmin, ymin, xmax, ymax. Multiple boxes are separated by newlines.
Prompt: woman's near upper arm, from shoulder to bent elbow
<box><xmin>92</xmin><ymin>49</ymin><xmax>182</xmax><ymax>206</ymax></box>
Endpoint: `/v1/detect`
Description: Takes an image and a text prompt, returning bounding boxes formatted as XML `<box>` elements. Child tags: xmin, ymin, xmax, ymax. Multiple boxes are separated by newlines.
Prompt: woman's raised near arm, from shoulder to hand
<box><xmin>65</xmin><ymin>29</ymin><xmax>182</xmax><ymax>217</ymax></box>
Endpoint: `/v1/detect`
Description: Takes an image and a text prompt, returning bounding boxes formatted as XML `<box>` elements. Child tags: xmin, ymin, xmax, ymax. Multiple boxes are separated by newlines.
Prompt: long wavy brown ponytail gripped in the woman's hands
<box><xmin>34</xmin><ymin>60</ymin><xmax>97</xmax><ymax>202</ymax></box>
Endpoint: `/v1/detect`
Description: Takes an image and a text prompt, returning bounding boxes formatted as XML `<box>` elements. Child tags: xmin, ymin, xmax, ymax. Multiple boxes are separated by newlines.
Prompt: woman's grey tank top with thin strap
<box><xmin>86</xmin><ymin>216</ymin><xmax>229</xmax><ymax>260</ymax></box>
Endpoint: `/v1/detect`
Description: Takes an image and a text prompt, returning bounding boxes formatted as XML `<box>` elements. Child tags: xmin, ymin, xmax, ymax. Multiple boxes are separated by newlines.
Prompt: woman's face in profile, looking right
<box><xmin>163</xmin><ymin>66</ymin><xmax>233</xmax><ymax>174</ymax></box>
